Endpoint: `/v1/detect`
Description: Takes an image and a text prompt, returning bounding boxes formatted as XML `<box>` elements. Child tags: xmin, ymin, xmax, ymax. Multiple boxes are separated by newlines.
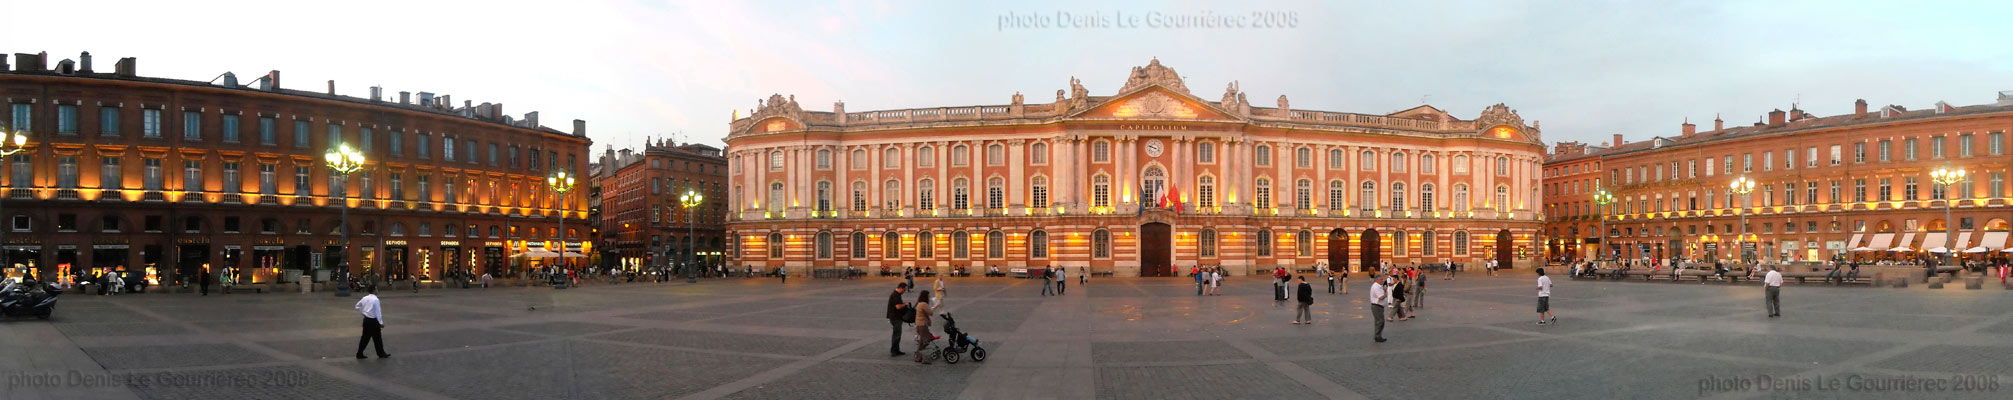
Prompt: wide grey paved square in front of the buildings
<box><xmin>0</xmin><ymin>271</ymin><xmax>2013</xmax><ymax>400</ymax></box>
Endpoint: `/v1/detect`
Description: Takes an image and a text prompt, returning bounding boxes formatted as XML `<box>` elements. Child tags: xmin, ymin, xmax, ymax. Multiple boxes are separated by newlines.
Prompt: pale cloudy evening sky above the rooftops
<box><xmin>0</xmin><ymin>0</ymin><xmax>2013</xmax><ymax>151</ymax></box>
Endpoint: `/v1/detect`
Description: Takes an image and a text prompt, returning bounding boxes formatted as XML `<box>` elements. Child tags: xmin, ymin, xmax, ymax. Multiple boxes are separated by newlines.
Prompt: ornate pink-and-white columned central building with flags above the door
<box><xmin>727</xmin><ymin>60</ymin><xmax>1544</xmax><ymax>275</ymax></box>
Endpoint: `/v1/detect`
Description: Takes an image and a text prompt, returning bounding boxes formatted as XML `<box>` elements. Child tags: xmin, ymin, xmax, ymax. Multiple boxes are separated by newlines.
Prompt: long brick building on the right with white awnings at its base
<box><xmin>1548</xmin><ymin>92</ymin><xmax>2013</xmax><ymax>261</ymax></box>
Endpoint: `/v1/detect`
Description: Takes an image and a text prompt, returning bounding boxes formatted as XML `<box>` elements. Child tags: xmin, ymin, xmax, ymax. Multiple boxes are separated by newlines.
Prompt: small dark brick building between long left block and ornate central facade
<box><xmin>598</xmin><ymin>141</ymin><xmax>727</xmax><ymax>269</ymax></box>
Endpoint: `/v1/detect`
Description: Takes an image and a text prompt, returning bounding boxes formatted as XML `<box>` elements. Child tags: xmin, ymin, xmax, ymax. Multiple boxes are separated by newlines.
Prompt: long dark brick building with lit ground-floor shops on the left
<box><xmin>0</xmin><ymin>52</ymin><xmax>590</xmax><ymax>283</ymax></box>
